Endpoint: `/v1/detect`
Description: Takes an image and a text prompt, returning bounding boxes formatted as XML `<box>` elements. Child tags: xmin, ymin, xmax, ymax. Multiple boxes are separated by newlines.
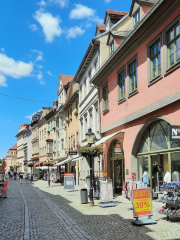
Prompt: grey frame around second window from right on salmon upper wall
<box><xmin>147</xmin><ymin>32</ymin><xmax>163</xmax><ymax>87</ymax></box>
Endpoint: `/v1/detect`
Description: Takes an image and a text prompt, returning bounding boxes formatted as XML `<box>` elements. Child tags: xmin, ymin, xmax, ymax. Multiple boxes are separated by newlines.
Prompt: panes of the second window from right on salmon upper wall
<box><xmin>151</xmin><ymin>41</ymin><xmax>161</xmax><ymax>80</ymax></box>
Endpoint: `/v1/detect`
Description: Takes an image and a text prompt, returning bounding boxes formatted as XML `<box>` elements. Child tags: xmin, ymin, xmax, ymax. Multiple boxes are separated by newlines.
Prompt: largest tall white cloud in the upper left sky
<box><xmin>34</xmin><ymin>10</ymin><xmax>62</xmax><ymax>43</ymax></box>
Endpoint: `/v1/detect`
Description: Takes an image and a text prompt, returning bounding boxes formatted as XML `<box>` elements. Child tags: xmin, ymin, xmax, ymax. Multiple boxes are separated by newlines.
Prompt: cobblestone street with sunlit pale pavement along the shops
<box><xmin>0</xmin><ymin>180</ymin><xmax>180</xmax><ymax>240</ymax></box>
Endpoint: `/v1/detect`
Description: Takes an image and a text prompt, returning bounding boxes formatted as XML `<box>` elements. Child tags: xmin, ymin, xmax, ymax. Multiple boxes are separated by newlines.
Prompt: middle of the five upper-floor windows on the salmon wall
<box><xmin>128</xmin><ymin>56</ymin><xmax>138</xmax><ymax>95</ymax></box>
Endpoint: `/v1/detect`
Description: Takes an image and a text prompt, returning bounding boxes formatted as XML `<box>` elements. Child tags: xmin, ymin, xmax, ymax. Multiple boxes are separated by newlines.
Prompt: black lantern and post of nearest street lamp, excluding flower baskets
<box><xmin>85</xmin><ymin>128</ymin><xmax>94</xmax><ymax>206</ymax></box>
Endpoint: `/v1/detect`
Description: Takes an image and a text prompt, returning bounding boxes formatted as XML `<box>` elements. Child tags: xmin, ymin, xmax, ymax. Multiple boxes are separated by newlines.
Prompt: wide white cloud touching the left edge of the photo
<box><xmin>0</xmin><ymin>53</ymin><xmax>33</xmax><ymax>80</ymax></box>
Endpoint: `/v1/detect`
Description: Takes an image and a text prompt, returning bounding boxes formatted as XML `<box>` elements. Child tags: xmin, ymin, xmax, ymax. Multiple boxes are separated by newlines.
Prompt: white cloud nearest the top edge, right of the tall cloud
<box><xmin>69</xmin><ymin>4</ymin><xmax>95</xmax><ymax>19</ymax></box>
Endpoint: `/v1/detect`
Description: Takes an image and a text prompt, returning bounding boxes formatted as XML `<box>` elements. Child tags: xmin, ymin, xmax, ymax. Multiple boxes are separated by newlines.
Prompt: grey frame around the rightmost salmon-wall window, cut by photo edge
<box><xmin>163</xmin><ymin>15</ymin><xmax>180</xmax><ymax>76</ymax></box>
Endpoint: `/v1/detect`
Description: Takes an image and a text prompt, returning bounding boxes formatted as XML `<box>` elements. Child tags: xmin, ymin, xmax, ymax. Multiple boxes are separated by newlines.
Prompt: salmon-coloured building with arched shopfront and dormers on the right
<box><xmin>91</xmin><ymin>0</ymin><xmax>180</xmax><ymax>193</ymax></box>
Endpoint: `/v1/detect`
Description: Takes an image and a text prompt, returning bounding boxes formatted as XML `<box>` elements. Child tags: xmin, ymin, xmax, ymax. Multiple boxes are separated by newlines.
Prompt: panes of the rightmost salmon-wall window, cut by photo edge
<box><xmin>167</xmin><ymin>23</ymin><xmax>180</xmax><ymax>67</ymax></box>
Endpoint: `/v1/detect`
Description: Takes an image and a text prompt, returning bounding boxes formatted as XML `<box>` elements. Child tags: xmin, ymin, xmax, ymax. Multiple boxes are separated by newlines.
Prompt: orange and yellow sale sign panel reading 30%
<box><xmin>133</xmin><ymin>188</ymin><xmax>152</xmax><ymax>217</ymax></box>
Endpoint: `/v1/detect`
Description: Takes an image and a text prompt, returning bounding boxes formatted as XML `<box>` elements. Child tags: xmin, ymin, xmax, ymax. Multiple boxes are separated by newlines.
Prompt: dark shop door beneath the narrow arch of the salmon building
<box><xmin>111</xmin><ymin>159</ymin><xmax>124</xmax><ymax>194</ymax></box>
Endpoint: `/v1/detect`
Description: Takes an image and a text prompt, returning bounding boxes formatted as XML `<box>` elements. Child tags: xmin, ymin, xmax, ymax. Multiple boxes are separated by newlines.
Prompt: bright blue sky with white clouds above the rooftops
<box><xmin>0</xmin><ymin>0</ymin><xmax>132</xmax><ymax>158</ymax></box>
